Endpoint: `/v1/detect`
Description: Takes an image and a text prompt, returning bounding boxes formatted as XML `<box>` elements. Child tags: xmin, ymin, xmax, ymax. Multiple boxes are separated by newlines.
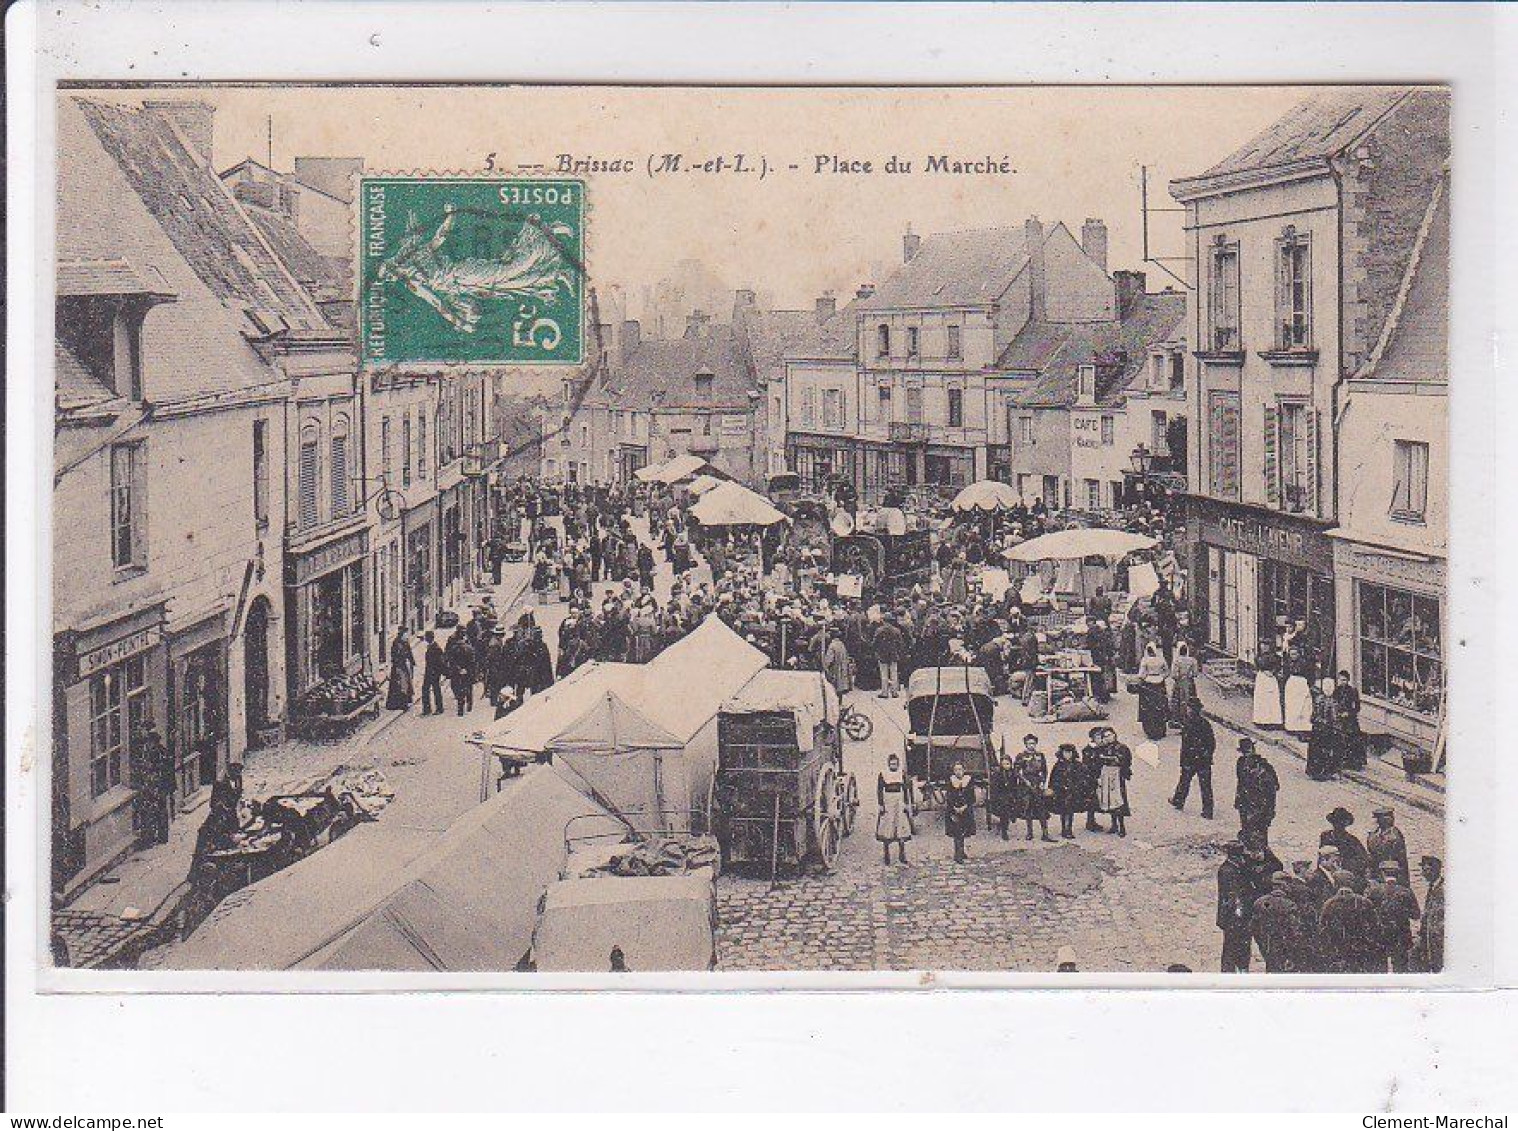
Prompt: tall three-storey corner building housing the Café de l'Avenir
<box><xmin>1170</xmin><ymin>88</ymin><xmax>1448</xmax><ymax>710</ymax></box>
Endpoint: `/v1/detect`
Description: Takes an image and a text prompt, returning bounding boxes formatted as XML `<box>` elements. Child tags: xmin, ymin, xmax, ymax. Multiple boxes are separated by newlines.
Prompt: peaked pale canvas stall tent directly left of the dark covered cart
<box><xmin>471</xmin><ymin>616</ymin><xmax>768</xmax><ymax>832</ymax></box>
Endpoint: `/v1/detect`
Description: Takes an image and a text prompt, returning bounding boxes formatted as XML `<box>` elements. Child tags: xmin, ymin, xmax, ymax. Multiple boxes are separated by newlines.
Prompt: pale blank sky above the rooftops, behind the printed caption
<box><xmin>71</xmin><ymin>87</ymin><xmax>1310</xmax><ymax>313</ymax></box>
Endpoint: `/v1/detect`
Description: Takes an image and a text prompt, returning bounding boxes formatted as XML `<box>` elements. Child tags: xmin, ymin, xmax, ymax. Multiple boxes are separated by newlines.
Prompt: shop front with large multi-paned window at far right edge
<box><xmin>1334</xmin><ymin>539</ymin><xmax>1445</xmax><ymax>750</ymax></box>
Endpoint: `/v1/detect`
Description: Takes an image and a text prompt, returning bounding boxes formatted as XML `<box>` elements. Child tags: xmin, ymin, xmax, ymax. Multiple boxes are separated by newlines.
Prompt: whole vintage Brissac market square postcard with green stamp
<box><xmin>44</xmin><ymin>82</ymin><xmax>1462</xmax><ymax>987</ymax></box>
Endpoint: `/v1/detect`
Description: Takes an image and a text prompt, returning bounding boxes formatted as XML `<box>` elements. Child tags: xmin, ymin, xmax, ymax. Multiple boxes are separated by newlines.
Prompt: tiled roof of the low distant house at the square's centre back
<box><xmin>597</xmin><ymin>325</ymin><xmax>754</xmax><ymax>411</ymax></box>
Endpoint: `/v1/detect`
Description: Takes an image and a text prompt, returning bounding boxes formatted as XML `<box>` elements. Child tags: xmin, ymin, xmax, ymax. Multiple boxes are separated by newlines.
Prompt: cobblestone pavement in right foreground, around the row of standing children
<box><xmin>718</xmin><ymin>689</ymin><xmax>1444</xmax><ymax>973</ymax></box>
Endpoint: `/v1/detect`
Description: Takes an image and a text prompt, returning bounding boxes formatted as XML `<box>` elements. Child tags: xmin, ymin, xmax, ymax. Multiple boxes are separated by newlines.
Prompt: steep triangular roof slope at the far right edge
<box><xmin>1362</xmin><ymin>173</ymin><xmax>1450</xmax><ymax>383</ymax></box>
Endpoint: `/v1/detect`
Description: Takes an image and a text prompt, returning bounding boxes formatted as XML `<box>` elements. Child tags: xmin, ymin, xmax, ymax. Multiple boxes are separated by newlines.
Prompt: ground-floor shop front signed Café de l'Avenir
<box><xmin>1186</xmin><ymin>495</ymin><xmax>1337</xmax><ymax>673</ymax></box>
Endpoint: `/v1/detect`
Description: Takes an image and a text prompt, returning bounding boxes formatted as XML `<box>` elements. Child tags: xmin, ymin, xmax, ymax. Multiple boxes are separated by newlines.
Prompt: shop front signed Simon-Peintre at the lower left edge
<box><xmin>52</xmin><ymin>601</ymin><xmax>170</xmax><ymax>891</ymax></box>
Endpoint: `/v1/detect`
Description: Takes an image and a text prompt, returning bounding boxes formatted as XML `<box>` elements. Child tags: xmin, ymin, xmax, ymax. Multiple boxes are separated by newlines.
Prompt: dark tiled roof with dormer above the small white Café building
<box><xmin>1013</xmin><ymin>291</ymin><xmax>1186</xmax><ymax>408</ymax></box>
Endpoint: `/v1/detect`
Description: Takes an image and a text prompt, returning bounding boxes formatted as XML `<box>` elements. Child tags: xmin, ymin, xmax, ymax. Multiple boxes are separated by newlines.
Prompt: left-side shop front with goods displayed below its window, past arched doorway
<box><xmin>285</xmin><ymin>530</ymin><xmax>369</xmax><ymax>701</ymax></box>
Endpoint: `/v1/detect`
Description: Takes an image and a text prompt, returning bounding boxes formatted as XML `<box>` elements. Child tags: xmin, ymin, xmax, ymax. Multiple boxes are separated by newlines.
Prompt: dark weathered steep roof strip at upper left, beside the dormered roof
<box><xmin>76</xmin><ymin>99</ymin><xmax>325</xmax><ymax>329</ymax></box>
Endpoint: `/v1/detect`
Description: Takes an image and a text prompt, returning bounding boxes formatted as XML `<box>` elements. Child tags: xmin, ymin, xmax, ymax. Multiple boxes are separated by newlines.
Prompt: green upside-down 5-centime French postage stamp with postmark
<box><xmin>358</xmin><ymin>176</ymin><xmax>584</xmax><ymax>366</ymax></box>
